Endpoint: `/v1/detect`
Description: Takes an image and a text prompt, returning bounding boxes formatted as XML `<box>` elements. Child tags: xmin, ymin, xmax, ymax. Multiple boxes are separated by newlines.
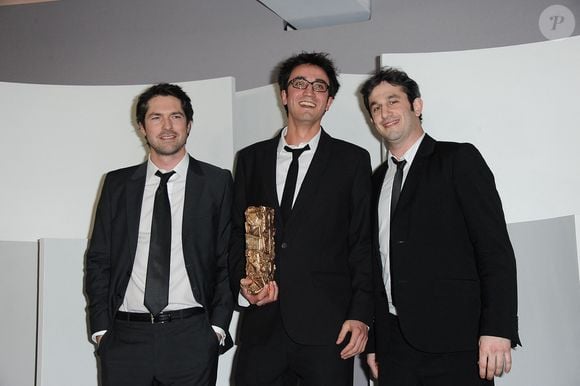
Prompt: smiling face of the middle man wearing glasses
<box><xmin>281</xmin><ymin>64</ymin><xmax>333</xmax><ymax>127</ymax></box>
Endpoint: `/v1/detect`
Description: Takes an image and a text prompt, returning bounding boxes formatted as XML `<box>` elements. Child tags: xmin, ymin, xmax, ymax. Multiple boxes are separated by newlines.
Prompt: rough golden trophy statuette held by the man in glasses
<box><xmin>245</xmin><ymin>206</ymin><xmax>276</xmax><ymax>295</ymax></box>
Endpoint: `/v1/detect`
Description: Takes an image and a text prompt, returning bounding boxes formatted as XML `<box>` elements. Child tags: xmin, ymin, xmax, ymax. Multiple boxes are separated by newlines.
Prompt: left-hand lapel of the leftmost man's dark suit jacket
<box><xmin>125</xmin><ymin>162</ymin><xmax>147</xmax><ymax>259</ymax></box>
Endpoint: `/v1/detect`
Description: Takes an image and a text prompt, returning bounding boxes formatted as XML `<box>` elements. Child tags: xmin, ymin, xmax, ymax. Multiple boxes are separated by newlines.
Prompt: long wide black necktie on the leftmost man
<box><xmin>144</xmin><ymin>170</ymin><xmax>175</xmax><ymax>315</ymax></box>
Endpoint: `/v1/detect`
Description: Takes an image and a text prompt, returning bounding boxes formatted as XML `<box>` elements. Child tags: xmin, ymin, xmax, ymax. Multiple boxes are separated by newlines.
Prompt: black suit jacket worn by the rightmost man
<box><xmin>373</xmin><ymin>135</ymin><xmax>519</xmax><ymax>352</ymax></box>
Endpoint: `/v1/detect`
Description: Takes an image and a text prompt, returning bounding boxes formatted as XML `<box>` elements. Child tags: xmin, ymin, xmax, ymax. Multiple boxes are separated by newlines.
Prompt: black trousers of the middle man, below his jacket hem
<box><xmin>234</xmin><ymin>318</ymin><xmax>354</xmax><ymax>386</ymax></box>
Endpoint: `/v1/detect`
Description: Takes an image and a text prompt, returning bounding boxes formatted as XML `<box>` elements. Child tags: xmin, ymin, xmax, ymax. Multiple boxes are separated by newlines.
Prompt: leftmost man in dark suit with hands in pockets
<box><xmin>86</xmin><ymin>84</ymin><xmax>233</xmax><ymax>386</ymax></box>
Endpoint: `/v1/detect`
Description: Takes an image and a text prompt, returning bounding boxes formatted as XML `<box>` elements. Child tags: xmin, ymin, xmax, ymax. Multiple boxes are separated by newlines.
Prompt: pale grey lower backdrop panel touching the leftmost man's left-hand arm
<box><xmin>36</xmin><ymin>239</ymin><xmax>97</xmax><ymax>386</ymax></box>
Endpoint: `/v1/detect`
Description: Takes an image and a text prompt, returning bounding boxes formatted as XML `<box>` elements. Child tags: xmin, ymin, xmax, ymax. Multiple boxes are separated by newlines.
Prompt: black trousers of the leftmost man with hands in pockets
<box><xmin>97</xmin><ymin>314</ymin><xmax>219</xmax><ymax>386</ymax></box>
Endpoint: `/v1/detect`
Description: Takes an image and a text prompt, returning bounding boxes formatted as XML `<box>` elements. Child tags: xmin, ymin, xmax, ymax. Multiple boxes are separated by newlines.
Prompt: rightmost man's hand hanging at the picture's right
<box><xmin>479</xmin><ymin>335</ymin><xmax>512</xmax><ymax>381</ymax></box>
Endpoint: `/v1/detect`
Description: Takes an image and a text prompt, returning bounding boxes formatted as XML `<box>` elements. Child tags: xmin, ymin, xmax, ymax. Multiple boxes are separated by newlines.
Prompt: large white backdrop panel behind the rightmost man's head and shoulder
<box><xmin>381</xmin><ymin>37</ymin><xmax>580</xmax><ymax>222</ymax></box>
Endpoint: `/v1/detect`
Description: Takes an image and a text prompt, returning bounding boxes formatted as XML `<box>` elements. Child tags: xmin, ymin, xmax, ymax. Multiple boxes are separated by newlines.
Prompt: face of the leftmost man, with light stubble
<box><xmin>139</xmin><ymin>95</ymin><xmax>191</xmax><ymax>162</ymax></box>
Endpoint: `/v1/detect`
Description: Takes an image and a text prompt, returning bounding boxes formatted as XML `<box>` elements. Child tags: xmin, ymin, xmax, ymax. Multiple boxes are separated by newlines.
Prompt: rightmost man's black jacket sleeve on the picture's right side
<box><xmin>454</xmin><ymin>144</ymin><xmax>520</xmax><ymax>345</ymax></box>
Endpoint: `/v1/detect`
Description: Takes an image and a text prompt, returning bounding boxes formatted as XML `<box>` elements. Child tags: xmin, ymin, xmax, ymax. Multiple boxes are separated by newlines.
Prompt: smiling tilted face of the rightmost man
<box><xmin>369</xmin><ymin>82</ymin><xmax>423</xmax><ymax>153</ymax></box>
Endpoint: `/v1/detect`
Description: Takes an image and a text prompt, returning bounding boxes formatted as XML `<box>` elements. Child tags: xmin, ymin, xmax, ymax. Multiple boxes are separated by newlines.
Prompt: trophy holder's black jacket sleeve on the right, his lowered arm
<box><xmin>348</xmin><ymin>151</ymin><xmax>373</xmax><ymax>326</ymax></box>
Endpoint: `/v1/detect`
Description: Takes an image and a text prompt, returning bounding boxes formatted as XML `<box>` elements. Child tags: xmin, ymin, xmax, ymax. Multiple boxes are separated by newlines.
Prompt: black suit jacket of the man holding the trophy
<box><xmin>230</xmin><ymin>131</ymin><xmax>373</xmax><ymax>344</ymax></box>
